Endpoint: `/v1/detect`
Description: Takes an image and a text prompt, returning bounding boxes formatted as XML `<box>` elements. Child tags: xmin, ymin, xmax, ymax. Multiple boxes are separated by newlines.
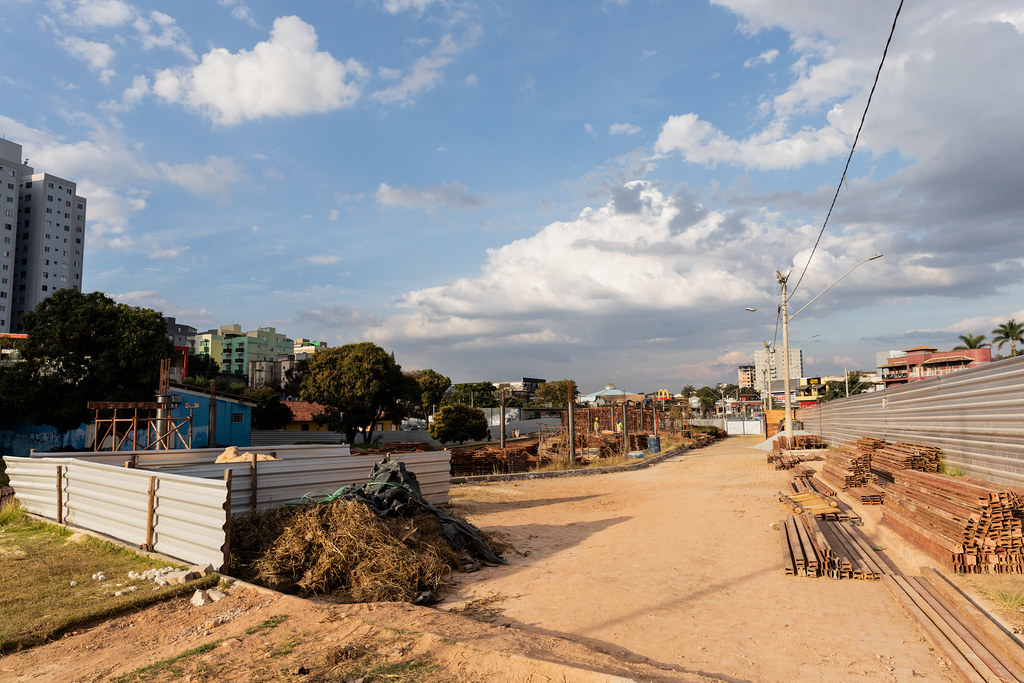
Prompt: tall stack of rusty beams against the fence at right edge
<box><xmin>882</xmin><ymin>470</ymin><xmax>1024</xmax><ymax>573</ymax></box>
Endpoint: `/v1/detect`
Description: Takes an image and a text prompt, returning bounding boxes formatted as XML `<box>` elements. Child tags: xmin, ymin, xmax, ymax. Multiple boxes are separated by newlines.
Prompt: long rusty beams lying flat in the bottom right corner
<box><xmin>883</xmin><ymin>567</ymin><xmax>1024</xmax><ymax>681</ymax></box>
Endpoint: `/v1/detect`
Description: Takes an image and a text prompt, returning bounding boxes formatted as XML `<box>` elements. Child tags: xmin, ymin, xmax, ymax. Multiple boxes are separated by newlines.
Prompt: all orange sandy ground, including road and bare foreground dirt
<box><xmin>0</xmin><ymin>437</ymin><xmax>983</xmax><ymax>681</ymax></box>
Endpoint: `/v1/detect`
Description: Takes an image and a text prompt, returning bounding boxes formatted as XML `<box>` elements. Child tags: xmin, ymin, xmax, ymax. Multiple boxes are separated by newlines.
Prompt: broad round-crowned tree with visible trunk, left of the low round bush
<box><xmin>300</xmin><ymin>342</ymin><xmax>403</xmax><ymax>443</ymax></box>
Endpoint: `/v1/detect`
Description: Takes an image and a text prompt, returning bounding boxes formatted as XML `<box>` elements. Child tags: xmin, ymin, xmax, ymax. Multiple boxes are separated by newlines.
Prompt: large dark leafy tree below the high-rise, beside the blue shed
<box><xmin>0</xmin><ymin>289</ymin><xmax>171</xmax><ymax>431</ymax></box>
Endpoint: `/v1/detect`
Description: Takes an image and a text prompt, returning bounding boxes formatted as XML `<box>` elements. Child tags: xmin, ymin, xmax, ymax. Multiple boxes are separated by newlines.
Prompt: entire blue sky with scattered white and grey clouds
<box><xmin>0</xmin><ymin>0</ymin><xmax>1024</xmax><ymax>392</ymax></box>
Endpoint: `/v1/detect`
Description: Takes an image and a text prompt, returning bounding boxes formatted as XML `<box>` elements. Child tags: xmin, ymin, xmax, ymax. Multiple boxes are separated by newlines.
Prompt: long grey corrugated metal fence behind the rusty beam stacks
<box><xmin>798</xmin><ymin>356</ymin><xmax>1024</xmax><ymax>486</ymax></box>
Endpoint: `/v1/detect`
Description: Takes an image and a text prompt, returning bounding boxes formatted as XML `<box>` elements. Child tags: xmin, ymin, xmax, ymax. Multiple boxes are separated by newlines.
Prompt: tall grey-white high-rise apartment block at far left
<box><xmin>0</xmin><ymin>138</ymin><xmax>86</xmax><ymax>332</ymax></box>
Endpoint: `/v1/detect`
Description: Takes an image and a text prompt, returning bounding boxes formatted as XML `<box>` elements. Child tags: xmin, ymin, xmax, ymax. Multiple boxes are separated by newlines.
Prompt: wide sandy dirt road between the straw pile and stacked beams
<box><xmin>449</xmin><ymin>437</ymin><xmax>954</xmax><ymax>681</ymax></box>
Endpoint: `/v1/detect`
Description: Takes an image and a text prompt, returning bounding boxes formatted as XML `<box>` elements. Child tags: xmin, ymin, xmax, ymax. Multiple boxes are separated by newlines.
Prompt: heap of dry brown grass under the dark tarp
<box><xmin>231</xmin><ymin>501</ymin><xmax>460</xmax><ymax>602</ymax></box>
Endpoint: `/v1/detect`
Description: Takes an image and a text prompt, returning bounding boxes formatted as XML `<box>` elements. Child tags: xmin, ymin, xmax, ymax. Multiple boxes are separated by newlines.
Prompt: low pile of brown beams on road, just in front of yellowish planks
<box><xmin>779</xmin><ymin>515</ymin><xmax>892</xmax><ymax>580</ymax></box>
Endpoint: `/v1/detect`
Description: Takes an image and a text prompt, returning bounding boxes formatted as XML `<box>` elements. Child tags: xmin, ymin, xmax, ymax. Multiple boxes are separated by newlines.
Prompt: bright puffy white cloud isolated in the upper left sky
<box><xmin>153</xmin><ymin>16</ymin><xmax>368</xmax><ymax>126</ymax></box>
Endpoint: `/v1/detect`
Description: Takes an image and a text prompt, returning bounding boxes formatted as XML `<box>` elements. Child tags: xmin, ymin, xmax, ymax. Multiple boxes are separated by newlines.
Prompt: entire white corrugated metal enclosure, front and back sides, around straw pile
<box><xmin>4</xmin><ymin>445</ymin><xmax>452</xmax><ymax>566</ymax></box>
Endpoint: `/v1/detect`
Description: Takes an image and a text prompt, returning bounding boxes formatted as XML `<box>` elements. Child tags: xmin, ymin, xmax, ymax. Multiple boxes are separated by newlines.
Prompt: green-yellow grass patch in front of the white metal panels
<box><xmin>0</xmin><ymin>506</ymin><xmax>220</xmax><ymax>655</ymax></box>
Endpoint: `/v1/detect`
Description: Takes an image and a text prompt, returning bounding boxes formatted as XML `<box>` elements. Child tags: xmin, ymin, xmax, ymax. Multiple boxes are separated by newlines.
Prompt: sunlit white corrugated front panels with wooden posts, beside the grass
<box><xmin>4</xmin><ymin>456</ymin><xmax>227</xmax><ymax>566</ymax></box>
